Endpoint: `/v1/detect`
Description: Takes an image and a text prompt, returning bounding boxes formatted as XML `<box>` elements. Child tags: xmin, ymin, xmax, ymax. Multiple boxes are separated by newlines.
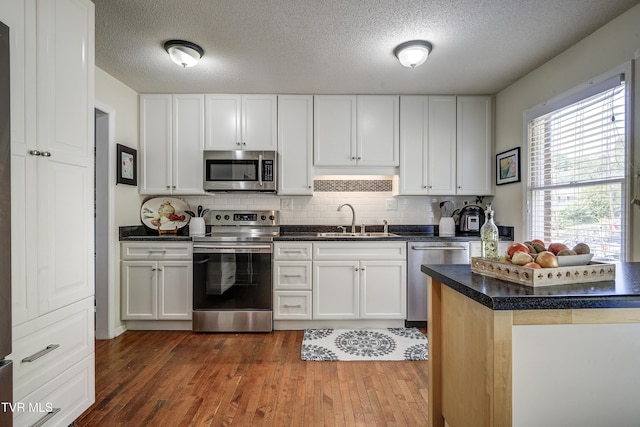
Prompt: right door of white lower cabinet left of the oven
<box><xmin>158</xmin><ymin>261</ymin><xmax>193</xmax><ymax>320</ymax></box>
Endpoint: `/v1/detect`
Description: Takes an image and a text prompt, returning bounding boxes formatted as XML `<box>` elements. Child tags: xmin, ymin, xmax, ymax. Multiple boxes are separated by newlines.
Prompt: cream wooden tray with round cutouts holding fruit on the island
<box><xmin>471</xmin><ymin>257</ymin><xmax>616</xmax><ymax>287</ymax></box>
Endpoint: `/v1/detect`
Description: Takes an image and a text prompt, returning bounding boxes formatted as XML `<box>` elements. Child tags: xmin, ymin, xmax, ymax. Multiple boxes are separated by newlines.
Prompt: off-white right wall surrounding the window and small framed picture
<box><xmin>494</xmin><ymin>5</ymin><xmax>640</xmax><ymax>261</ymax></box>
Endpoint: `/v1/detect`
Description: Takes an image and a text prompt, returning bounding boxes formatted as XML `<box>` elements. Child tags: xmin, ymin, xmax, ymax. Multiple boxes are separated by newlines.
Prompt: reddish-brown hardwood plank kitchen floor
<box><xmin>76</xmin><ymin>331</ymin><xmax>428</xmax><ymax>427</ymax></box>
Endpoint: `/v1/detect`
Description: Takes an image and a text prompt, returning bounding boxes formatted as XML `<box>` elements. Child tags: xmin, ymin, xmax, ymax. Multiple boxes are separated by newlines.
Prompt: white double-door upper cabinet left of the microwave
<box><xmin>140</xmin><ymin>94</ymin><xmax>204</xmax><ymax>194</ymax></box>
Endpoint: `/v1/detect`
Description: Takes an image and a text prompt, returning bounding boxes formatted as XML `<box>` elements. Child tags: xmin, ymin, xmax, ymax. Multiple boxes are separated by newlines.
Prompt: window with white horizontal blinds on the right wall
<box><xmin>525</xmin><ymin>69</ymin><xmax>629</xmax><ymax>260</ymax></box>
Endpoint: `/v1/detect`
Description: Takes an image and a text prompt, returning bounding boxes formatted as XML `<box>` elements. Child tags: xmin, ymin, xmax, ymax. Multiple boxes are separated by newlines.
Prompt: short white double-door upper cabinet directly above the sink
<box><xmin>314</xmin><ymin>95</ymin><xmax>399</xmax><ymax>167</ymax></box>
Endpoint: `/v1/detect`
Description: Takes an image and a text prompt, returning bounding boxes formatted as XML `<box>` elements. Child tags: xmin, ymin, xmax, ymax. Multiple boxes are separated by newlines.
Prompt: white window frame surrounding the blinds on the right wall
<box><xmin>521</xmin><ymin>62</ymin><xmax>640</xmax><ymax>261</ymax></box>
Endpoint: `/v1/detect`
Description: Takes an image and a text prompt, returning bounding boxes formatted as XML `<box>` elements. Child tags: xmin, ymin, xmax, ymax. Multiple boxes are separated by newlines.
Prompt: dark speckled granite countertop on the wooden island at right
<box><xmin>421</xmin><ymin>262</ymin><xmax>640</xmax><ymax>310</ymax></box>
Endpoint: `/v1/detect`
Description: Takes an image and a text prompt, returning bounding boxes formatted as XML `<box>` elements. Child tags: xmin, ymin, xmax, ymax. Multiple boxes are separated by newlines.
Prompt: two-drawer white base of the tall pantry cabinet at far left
<box><xmin>9</xmin><ymin>297</ymin><xmax>95</xmax><ymax>426</ymax></box>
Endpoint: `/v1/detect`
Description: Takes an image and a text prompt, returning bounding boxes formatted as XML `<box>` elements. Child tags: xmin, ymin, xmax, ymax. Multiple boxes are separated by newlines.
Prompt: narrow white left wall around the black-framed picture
<box><xmin>95</xmin><ymin>67</ymin><xmax>142</xmax><ymax>335</ymax></box>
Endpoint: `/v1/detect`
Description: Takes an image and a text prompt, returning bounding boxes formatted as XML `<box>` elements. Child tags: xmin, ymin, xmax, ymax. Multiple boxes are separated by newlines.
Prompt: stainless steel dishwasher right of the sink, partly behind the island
<box><xmin>406</xmin><ymin>241</ymin><xmax>469</xmax><ymax>327</ymax></box>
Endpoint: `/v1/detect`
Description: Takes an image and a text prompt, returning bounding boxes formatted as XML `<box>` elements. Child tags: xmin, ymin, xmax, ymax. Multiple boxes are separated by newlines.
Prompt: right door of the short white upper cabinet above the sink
<box><xmin>356</xmin><ymin>95</ymin><xmax>400</xmax><ymax>166</ymax></box>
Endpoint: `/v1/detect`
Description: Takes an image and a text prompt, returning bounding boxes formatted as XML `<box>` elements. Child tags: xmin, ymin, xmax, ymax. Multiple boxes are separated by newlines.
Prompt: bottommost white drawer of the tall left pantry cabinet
<box><xmin>13</xmin><ymin>354</ymin><xmax>95</xmax><ymax>427</ymax></box>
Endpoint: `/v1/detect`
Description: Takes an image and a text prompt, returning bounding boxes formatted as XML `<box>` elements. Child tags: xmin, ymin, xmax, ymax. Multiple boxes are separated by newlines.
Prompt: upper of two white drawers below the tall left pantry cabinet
<box><xmin>10</xmin><ymin>298</ymin><xmax>94</xmax><ymax>401</ymax></box>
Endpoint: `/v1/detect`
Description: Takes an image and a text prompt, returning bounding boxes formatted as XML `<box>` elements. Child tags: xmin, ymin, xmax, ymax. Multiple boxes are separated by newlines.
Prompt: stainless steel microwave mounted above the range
<box><xmin>203</xmin><ymin>150</ymin><xmax>277</xmax><ymax>192</ymax></box>
